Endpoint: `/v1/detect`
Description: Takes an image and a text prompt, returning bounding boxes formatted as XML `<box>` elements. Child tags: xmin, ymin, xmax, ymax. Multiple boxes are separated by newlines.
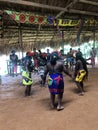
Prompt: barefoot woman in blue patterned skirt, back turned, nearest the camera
<box><xmin>43</xmin><ymin>53</ymin><xmax>71</xmax><ymax>111</ymax></box>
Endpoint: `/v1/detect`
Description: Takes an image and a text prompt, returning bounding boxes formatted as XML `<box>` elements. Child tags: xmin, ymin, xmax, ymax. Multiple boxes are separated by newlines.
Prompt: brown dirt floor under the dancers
<box><xmin>0</xmin><ymin>68</ymin><xmax>98</xmax><ymax>130</ymax></box>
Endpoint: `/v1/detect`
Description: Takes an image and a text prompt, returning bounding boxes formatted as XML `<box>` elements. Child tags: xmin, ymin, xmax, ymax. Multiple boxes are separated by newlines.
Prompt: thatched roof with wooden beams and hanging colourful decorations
<box><xmin>0</xmin><ymin>0</ymin><xmax>98</xmax><ymax>53</ymax></box>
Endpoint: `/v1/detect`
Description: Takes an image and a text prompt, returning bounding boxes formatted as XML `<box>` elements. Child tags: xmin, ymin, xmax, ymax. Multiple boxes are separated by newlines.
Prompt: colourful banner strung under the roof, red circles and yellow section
<box><xmin>4</xmin><ymin>10</ymin><xmax>98</xmax><ymax>26</ymax></box>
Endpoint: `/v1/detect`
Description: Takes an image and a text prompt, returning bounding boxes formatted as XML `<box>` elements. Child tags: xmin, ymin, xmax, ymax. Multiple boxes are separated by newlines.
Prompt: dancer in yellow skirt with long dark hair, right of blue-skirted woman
<box><xmin>74</xmin><ymin>54</ymin><xmax>89</xmax><ymax>95</ymax></box>
